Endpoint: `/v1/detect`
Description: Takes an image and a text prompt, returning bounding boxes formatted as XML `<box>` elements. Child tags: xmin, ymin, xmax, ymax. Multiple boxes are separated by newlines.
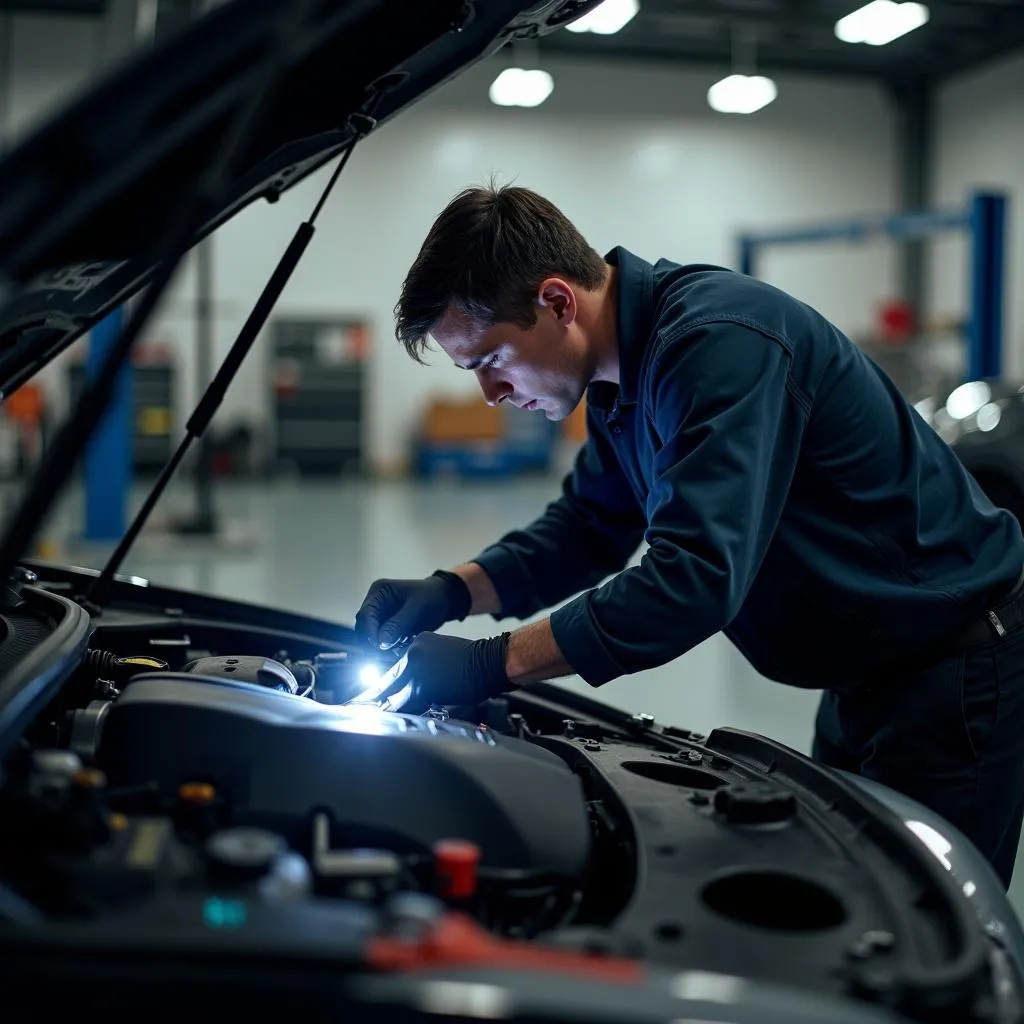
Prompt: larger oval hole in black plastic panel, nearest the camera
<box><xmin>701</xmin><ymin>871</ymin><xmax>846</xmax><ymax>932</ymax></box>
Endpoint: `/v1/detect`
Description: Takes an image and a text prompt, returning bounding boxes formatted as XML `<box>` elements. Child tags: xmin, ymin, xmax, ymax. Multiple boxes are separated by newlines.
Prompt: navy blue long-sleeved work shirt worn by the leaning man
<box><xmin>476</xmin><ymin>248</ymin><xmax>1024</xmax><ymax>687</ymax></box>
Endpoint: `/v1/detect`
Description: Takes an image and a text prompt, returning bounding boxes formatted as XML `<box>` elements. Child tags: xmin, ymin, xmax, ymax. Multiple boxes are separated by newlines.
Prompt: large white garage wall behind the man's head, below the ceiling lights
<box><xmin>4</xmin><ymin>14</ymin><xmax>895</xmax><ymax>464</ymax></box>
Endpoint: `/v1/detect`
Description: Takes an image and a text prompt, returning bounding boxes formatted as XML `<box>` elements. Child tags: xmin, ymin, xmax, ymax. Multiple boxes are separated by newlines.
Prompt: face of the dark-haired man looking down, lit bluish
<box><xmin>431</xmin><ymin>278</ymin><xmax>595</xmax><ymax>420</ymax></box>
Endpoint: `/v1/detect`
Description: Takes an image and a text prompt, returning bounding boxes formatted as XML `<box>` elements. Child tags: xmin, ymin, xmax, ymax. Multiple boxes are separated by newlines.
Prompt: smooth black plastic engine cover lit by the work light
<box><xmin>97</xmin><ymin>673</ymin><xmax>590</xmax><ymax>879</ymax></box>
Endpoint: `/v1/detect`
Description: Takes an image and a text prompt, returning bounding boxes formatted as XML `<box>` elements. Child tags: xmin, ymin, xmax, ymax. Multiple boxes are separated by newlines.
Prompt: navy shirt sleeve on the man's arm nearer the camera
<box><xmin>551</xmin><ymin>322</ymin><xmax>806</xmax><ymax>686</ymax></box>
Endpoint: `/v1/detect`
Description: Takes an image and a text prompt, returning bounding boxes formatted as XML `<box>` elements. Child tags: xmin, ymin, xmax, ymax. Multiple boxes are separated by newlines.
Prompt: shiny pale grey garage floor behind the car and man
<box><xmin>36</xmin><ymin>479</ymin><xmax>1024</xmax><ymax>915</ymax></box>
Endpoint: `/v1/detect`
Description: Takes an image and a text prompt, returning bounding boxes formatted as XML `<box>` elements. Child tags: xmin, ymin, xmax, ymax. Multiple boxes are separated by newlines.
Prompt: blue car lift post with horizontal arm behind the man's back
<box><xmin>739</xmin><ymin>191</ymin><xmax>1007</xmax><ymax>380</ymax></box>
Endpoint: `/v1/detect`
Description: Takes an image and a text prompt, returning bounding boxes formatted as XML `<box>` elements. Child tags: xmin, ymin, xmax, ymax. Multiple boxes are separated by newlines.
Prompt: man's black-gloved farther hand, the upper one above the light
<box><xmin>355</xmin><ymin>570</ymin><xmax>472</xmax><ymax>650</ymax></box>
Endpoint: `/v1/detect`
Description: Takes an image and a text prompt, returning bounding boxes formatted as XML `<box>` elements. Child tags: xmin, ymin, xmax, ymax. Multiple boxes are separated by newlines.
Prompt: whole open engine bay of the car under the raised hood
<box><xmin>0</xmin><ymin>568</ymin><xmax>1019</xmax><ymax>1022</ymax></box>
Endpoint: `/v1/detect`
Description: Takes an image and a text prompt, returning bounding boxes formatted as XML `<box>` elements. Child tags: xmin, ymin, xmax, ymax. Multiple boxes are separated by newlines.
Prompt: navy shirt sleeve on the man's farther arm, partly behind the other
<box><xmin>474</xmin><ymin>403</ymin><xmax>646</xmax><ymax>618</ymax></box>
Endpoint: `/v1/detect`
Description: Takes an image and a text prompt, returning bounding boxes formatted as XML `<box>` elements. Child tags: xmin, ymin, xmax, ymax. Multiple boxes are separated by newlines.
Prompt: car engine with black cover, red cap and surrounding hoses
<box><xmin>0</xmin><ymin>638</ymin><xmax>591</xmax><ymax>935</ymax></box>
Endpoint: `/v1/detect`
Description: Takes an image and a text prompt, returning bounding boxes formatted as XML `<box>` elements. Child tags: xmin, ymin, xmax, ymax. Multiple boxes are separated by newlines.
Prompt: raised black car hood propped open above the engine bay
<box><xmin>0</xmin><ymin>0</ymin><xmax>597</xmax><ymax>397</ymax></box>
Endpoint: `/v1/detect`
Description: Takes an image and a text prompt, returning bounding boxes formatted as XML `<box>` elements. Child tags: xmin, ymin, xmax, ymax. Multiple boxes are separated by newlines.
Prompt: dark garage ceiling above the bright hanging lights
<box><xmin>6</xmin><ymin>0</ymin><xmax>1024</xmax><ymax>81</ymax></box>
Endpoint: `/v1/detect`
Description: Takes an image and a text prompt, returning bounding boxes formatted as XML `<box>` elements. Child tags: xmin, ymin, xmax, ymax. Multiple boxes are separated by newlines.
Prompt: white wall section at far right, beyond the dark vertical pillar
<box><xmin>929</xmin><ymin>53</ymin><xmax>1024</xmax><ymax>375</ymax></box>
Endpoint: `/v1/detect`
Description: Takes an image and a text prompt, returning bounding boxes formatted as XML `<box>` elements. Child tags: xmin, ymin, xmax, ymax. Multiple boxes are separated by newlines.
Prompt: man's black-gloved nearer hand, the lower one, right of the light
<box><xmin>395</xmin><ymin>633</ymin><xmax>514</xmax><ymax>706</ymax></box>
